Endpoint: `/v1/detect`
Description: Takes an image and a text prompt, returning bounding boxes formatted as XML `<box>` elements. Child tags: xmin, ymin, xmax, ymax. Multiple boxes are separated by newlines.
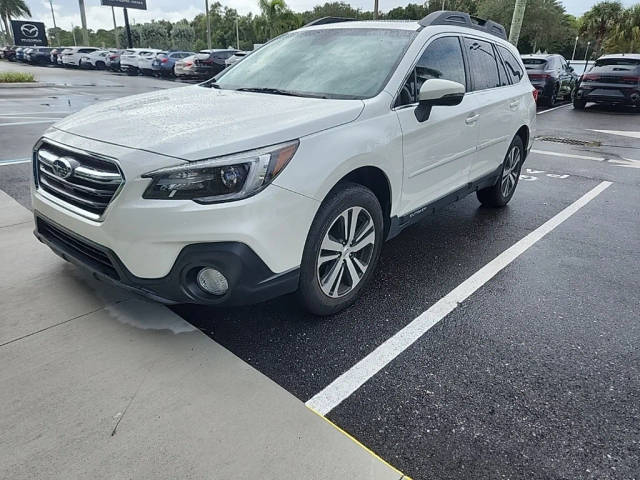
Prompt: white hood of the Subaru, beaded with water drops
<box><xmin>53</xmin><ymin>86</ymin><xmax>364</xmax><ymax>160</ymax></box>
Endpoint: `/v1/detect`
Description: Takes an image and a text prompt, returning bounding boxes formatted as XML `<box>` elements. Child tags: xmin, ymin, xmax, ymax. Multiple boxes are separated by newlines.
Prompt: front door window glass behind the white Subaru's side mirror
<box><xmin>396</xmin><ymin>37</ymin><xmax>467</xmax><ymax>106</ymax></box>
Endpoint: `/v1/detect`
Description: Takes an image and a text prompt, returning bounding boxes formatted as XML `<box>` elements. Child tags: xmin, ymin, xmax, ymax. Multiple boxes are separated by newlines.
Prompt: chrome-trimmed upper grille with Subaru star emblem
<box><xmin>34</xmin><ymin>143</ymin><xmax>124</xmax><ymax>220</ymax></box>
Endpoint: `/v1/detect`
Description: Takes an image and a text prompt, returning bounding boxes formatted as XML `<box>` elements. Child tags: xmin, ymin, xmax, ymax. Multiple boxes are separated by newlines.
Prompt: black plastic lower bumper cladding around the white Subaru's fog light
<box><xmin>34</xmin><ymin>213</ymin><xmax>299</xmax><ymax>305</ymax></box>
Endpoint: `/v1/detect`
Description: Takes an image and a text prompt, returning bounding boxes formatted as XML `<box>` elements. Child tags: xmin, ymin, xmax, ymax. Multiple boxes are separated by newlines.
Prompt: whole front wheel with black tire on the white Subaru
<box><xmin>298</xmin><ymin>182</ymin><xmax>384</xmax><ymax>316</ymax></box>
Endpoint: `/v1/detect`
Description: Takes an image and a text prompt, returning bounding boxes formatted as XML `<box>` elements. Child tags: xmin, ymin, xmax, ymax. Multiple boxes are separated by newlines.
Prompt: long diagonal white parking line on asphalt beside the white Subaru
<box><xmin>306</xmin><ymin>182</ymin><xmax>612</xmax><ymax>415</ymax></box>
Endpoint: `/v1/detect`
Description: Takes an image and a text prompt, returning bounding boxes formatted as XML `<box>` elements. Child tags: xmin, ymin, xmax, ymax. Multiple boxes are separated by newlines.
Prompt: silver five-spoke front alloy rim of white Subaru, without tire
<box><xmin>316</xmin><ymin>207</ymin><xmax>376</xmax><ymax>298</ymax></box>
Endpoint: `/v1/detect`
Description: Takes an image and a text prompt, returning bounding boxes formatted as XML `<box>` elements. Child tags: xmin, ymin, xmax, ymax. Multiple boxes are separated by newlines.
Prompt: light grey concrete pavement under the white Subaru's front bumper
<box><xmin>0</xmin><ymin>192</ymin><xmax>402</xmax><ymax>480</ymax></box>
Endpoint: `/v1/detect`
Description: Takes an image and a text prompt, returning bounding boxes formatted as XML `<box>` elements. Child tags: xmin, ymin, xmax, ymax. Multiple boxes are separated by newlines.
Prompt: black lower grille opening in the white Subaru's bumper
<box><xmin>36</xmin><ymin>217</ymin><xmax>120</xmax><ymax>280</ymax></box>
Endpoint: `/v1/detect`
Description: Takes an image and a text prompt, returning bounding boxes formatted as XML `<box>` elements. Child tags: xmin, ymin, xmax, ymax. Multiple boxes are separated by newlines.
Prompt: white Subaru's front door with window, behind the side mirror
<box><xmin>395</xmin><ymin>35</ymin><xmax>477</xmax><ymax>213</ymax></box>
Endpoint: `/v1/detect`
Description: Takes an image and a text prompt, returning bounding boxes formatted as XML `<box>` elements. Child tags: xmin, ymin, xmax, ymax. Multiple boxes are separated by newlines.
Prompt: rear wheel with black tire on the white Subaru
<box><xmin>476</xmin><ymin>135</ymin><xmax>524</xmax><ymax>208</ymax></box>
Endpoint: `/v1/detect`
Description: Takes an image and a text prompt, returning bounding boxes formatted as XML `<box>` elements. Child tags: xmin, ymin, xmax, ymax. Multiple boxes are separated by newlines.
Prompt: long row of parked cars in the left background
<box><xmin>0</xmin><ymin>46</ymin><xmax>248</xmax><ymax>78</ymax></box>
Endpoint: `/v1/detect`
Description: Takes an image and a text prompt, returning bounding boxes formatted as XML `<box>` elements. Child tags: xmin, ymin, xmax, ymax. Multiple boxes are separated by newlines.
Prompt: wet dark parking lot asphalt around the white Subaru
<box><xmin>0</xmin><ymin>62</ymin><xmax>640</xmax><ymax>479</ymax></box>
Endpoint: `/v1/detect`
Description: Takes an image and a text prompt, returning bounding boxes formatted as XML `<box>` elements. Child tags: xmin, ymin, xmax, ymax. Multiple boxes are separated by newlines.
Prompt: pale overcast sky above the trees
<box><xmin>11</xmin><ymin>0</ymin><xmax>638</xmax><ymax>30</ymax></box>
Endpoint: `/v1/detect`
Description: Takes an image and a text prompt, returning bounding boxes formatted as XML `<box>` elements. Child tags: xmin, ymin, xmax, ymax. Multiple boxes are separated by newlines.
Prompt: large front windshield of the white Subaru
<box><xmin>217</xmin><ymin>28</ymin><xmax>414</xmax><ymax>98</ymax></box>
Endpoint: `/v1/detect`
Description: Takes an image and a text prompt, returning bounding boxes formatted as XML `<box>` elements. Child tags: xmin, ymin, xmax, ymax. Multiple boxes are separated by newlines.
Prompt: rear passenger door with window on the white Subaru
<box><xmin>464</xmin><ymin>37</ymin><xmax>520</xmax><ymax>182</ymax></box>
